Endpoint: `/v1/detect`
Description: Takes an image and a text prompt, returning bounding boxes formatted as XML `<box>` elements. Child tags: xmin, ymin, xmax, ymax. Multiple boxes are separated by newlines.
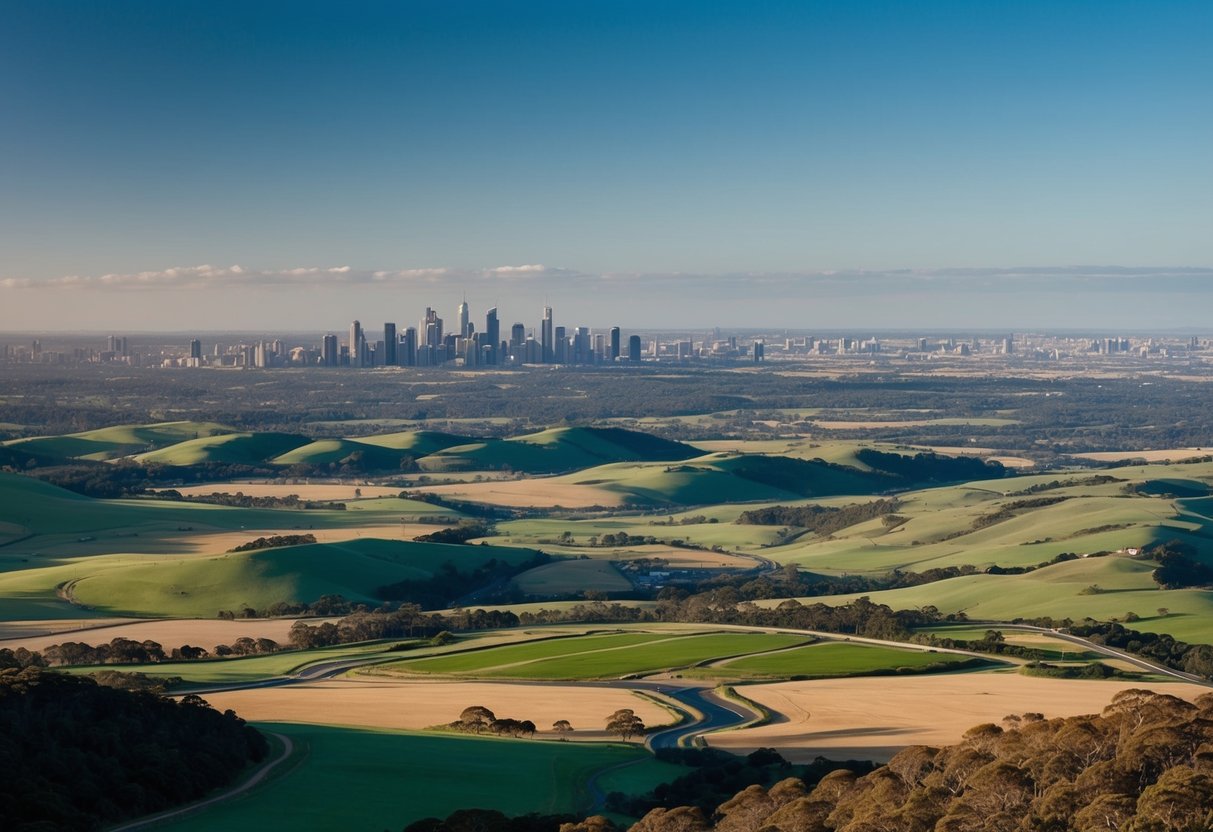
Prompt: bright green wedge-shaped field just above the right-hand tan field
<box><xmin>705</xmin><ymin>642</ymin><xmax>968</xmax><ymax>678</ymax></box>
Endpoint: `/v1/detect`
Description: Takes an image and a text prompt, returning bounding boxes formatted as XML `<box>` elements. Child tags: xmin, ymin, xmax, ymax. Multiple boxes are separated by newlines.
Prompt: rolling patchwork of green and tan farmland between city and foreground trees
<box><xmin>0</xmin><ymin>409</ymin><xmax>1213</xmax><ymax>832</ymax></box>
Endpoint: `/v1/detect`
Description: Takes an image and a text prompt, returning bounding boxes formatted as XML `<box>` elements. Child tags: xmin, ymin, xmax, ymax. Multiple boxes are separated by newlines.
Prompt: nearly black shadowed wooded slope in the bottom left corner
<box><xmin>0</xmin><ymin>667</ymin><xmax>269</xmax><ymax>832</ymax></box>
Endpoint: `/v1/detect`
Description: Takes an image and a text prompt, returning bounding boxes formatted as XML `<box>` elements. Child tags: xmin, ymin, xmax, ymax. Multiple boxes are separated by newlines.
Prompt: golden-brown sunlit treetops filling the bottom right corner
<box><xmin>611</xmin><ymin>689</ymin><xmax>1213</xmax><ymax>832</ymax></box>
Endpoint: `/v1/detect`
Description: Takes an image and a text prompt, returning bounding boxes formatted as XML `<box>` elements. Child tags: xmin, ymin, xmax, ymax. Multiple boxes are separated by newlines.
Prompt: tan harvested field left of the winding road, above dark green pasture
<box><xmin>195</xmin><ymin>676</ymin><xmax>673</xmax><ymax>737</ymax></box>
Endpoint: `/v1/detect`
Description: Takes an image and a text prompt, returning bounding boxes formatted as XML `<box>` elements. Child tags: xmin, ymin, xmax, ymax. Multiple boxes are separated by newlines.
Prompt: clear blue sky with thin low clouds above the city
<box><xmin>0</xmin><ymin>0</ymin><xmax>1213</xmax><ymax>329</ymax></box>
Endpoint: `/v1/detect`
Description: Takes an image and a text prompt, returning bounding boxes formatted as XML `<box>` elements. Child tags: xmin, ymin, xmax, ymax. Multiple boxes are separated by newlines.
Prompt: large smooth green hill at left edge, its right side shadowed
<box><xmin>0</xmin><ymin>538</ymin><xmax>534</xmax><ymax>617</ymax></box>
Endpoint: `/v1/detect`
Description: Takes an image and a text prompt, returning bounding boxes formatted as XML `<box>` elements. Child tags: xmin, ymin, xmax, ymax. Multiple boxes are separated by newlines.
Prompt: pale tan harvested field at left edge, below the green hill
<box><xmin>0</xmin><ymin>619</ymin><xmax>330</xmax><ymax>650</ymax></box>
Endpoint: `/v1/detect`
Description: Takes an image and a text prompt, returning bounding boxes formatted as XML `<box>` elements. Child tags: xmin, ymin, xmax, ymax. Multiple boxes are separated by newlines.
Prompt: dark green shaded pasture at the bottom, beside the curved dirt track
<box><xmin>158</xmin><ymin>723</ymin><xmax>671</xmax><ymax>832</ymax></box>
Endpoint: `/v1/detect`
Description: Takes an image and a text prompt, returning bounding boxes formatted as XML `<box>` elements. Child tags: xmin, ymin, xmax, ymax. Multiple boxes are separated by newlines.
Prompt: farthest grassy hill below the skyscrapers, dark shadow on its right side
<box><xmin>421</xmin><ymin>427</ymin><xmax>701</xmax><ymax>474</ymax></box>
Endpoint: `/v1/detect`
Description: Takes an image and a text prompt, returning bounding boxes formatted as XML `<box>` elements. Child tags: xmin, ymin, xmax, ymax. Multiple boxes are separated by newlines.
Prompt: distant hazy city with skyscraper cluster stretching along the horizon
<box><xmin>0</xmin><ymin>300</ymin><xmax>1213</xmax><ymax>370</ymax></box>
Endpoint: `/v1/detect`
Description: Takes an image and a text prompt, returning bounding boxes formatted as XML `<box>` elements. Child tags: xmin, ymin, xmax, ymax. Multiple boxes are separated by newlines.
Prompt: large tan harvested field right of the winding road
<box><xmin>707</xmin><ymin>672</ymin><xmax>1209</xmax><ymax>762</ymax></box>
